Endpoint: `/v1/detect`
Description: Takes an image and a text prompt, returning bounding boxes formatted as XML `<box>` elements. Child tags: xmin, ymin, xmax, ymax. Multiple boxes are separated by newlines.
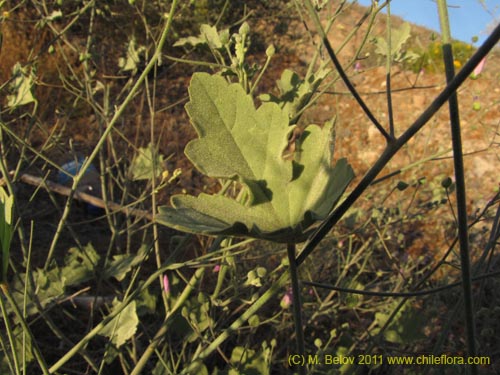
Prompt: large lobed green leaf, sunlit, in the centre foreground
<box><xmin>157</xmin><ymin>73</ymin><xmax>353</xmax><ymax>242</ymax></box>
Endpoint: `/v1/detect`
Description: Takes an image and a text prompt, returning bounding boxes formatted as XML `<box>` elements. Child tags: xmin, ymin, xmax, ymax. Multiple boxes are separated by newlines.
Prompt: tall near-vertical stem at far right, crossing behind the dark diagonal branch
<box><xmin>438</xmin><ymin>0</ymin><xmax>477</xmax><ymax>374</ymax></box>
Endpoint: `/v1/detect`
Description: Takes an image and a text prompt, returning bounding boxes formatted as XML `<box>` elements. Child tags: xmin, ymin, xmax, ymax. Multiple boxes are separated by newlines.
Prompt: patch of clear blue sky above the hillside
<box><xmin>358</xmin><ymin>0</ymin><xmax>500</xmax><ymax>46</ymax></box>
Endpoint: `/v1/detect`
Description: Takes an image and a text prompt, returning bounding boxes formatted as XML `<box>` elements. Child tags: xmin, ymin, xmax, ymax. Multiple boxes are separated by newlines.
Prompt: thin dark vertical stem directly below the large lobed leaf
<box><xmin>287</xmin><ymin>243</ymin><xmax>307</xmax><ymax>375</ymax></box>
